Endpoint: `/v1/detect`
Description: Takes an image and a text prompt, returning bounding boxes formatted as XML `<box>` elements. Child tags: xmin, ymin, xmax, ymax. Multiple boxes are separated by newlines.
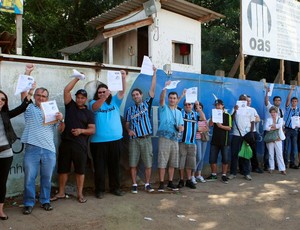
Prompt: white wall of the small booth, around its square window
<box><xmin>149</xmin><ymin>9</ymin><xmax>201</xmax><ymax>73</ymax></box>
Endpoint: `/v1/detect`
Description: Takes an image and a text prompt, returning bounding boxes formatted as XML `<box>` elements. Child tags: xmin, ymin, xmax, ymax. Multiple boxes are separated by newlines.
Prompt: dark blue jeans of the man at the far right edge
<box><xmin>283</xmin><ymin>128</ymin><xmax>298</xmax><ymax>165</ymax></box>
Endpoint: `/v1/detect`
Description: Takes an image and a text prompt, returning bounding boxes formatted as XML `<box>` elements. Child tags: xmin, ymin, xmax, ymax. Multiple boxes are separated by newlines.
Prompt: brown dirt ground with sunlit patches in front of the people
<box><xmin>0</xmin><ymin>169</ymin><xmax>300</xmax><ymax>230</ymax></box>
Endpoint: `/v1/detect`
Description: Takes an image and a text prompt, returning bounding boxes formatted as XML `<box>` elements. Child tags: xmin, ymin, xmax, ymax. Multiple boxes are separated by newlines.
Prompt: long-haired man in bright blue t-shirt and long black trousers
<box><xmin>89</xmin><ymin>70</ymin><xmax>126</xmax><ymax>199</ymax></box>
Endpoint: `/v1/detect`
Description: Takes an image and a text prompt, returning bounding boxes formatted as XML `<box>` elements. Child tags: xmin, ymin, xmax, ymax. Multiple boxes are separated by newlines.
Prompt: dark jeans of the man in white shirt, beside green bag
<box><xmin>230</xmin><ymin>135</ymin><xmax>250</xmax><ymax>176</ymax></box>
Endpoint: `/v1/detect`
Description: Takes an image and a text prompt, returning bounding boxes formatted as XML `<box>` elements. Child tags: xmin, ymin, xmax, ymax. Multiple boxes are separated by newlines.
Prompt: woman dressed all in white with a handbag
<box><xmin>265</xmin><ymin>106</ymin><xmax>286</xmax><ymax>175</ymax></box>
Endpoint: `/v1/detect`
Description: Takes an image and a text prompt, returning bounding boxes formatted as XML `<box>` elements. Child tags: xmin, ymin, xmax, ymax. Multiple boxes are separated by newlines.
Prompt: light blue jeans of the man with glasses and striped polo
<box><xmin>23</xmin><ymin>144</ymin><xmax>56</xmax><ymax>207</ymax></box>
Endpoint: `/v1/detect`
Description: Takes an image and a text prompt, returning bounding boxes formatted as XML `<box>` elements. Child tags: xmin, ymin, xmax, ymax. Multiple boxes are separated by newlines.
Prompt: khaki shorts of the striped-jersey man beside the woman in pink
<box><xmin>179</xmin><ymin>143</ymin><xmax>196</xmax><ymax>169</ymax></box>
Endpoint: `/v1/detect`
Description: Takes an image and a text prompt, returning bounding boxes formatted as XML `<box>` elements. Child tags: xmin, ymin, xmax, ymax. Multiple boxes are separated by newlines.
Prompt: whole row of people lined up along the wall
<box><xmin>0</xmin><ymin>64</ymin><xmax>300</xmax><ymax>220</ymax></box>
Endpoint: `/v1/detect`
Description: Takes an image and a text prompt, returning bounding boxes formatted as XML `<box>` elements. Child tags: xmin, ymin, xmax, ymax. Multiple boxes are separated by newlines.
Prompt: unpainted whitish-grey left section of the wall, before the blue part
<box><xmin>0</xmin><ymin>55</ymin><xmax>137</xmax><ymax>196</ymax></box>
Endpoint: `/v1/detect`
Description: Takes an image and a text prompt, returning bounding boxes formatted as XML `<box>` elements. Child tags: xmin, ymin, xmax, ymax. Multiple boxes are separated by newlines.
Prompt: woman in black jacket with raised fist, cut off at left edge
<box><xmin>0</xmin><ymin>84</ymin><xmax>35</xmax><ymax>220</ymax></box>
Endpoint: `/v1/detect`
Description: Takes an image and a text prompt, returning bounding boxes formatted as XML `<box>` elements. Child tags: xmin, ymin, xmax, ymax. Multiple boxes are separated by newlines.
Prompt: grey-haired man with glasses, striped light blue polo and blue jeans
<box><xmin>21</xmin><ymin>67</ymin><xmax>63</xmax><ymax>215</ymax></box>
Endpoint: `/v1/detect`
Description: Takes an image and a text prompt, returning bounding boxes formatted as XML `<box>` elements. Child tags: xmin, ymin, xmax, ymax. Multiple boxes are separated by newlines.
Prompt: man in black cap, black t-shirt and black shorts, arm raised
<box><xmin>51</xmin><ymin>76</ymin><xmax>95</xmax><ymax>203</ymax></box>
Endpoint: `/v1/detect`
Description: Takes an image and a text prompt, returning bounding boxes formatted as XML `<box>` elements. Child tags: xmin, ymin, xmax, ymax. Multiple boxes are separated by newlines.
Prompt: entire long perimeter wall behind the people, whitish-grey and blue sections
<box><xmin>0</xmin><ymin>55</ymin><xmax>292</xmax><ymax>196</ymax></box>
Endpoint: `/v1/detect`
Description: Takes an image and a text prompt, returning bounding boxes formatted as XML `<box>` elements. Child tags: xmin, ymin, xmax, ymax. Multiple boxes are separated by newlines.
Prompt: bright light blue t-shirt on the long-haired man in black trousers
<box><xmin>89</xmin><ymin>94</ymin><xmax>123</xmax><ymax>143</ymax></box>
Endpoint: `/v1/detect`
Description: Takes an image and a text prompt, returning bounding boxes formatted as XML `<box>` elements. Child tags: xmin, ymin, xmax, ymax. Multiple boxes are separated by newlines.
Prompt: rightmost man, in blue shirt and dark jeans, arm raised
<box><xmin>283</xmin><ymin>85</ymin><xmax>300</xmax><ymax>169</ymax></box>
